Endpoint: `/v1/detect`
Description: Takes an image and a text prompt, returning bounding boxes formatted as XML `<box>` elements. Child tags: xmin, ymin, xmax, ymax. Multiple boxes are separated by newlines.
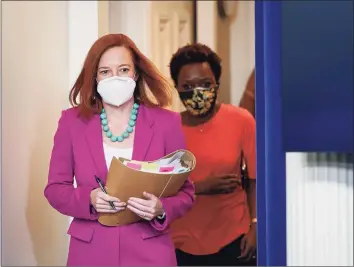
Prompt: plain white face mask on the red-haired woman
<box><xmin>97</xmin><ymin>76</ymin><xmax>136</xmax><ymax>107</ymax></box>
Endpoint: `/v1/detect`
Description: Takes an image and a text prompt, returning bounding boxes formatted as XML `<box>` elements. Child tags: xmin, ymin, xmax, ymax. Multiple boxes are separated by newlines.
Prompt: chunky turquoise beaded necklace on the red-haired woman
<box><xmin>100</xmin><ymin>103</ymin><xmax>139</xmax><ymax>142</ymax></box>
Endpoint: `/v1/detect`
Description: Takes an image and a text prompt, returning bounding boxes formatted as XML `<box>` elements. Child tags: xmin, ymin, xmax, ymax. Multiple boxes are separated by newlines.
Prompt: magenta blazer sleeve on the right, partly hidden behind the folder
<box><xmin>150</xmin><ymin>113</ymin><xmax>195</xmax><ymax>231</ymax></box>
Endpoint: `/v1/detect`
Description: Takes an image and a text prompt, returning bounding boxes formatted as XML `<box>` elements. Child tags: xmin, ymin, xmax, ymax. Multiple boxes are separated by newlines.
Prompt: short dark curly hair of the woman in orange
<box><xmin>169</xmin><ymin>43</ymin><xmax>221</xmax><ymax>86</ymax></box>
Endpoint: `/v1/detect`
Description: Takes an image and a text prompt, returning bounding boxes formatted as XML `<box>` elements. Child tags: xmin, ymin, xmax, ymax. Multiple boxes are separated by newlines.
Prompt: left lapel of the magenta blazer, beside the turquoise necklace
<box><xmin>85</xmin><ymin>115</ymin><xmax>108</xmax><ymax>181</ymax></box>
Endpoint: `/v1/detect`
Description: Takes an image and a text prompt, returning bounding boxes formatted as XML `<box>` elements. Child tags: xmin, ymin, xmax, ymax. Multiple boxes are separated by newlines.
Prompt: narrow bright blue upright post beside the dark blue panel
<box><xmin>255</xmin><ymin>1</ymin><xmax>286</xmax><ymax>266</ymax></box>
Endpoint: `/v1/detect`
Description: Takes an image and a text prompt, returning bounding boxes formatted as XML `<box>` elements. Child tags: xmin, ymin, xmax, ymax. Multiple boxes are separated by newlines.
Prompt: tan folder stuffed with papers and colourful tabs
<box><xmin>98</xmin><ymin>150</ymin><xmax>196</xmax><ymax>226</ymax></box>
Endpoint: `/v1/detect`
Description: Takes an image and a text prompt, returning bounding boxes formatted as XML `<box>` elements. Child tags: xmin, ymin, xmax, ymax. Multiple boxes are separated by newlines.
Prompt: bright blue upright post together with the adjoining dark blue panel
<box><xmin>255</xmin><ymin>0</ymin><xmax>353</xmax><ymax>266</ymax></box>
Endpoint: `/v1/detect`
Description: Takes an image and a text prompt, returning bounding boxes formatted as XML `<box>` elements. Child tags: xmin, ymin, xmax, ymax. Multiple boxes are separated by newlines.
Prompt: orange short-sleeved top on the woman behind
<box><xmin>171</xmin><ymin>104</ymin><xmax>256</xmax><ymax>255</ymax></box>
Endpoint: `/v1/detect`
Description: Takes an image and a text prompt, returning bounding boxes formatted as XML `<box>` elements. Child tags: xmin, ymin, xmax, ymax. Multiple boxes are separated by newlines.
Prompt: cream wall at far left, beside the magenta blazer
<box><xmin>1</xmin><ymin>1</ymin><xmax>68</xmax><ymax>266</ymax></box>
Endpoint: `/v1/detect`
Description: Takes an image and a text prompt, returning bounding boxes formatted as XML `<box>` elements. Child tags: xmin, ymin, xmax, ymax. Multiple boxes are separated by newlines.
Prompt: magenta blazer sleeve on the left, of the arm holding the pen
<box><xmin>44</xmin><ymin>111</ymin><xmax>98</xmax><ymax>220</ymax></box>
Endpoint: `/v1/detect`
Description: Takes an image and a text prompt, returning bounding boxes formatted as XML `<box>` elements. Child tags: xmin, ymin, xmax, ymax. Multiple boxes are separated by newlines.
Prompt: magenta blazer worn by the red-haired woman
<box><xmin>44</xmin><ymin>105</ymin><xmax>195</xmax><ymax>266</ymax></box>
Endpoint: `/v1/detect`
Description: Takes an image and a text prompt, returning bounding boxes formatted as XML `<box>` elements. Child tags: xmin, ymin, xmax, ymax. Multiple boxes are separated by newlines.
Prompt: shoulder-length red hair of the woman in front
<box><xmin>69</xmin><ymin>34</ymin><xmax>172</xmax><ymax>118</ymax></box>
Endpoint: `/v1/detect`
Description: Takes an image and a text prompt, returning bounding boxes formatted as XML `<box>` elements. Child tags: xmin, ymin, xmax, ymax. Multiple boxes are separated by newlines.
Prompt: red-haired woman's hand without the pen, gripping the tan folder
<box><xmin>127</xmin><ymin>192</ymin><xmax>164</xmax><ymax>221</ymax></box>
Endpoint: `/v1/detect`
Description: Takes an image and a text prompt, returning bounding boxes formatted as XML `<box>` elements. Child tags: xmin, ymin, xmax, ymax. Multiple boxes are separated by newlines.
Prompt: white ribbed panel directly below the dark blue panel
<box><xmin>286</xmin><ymin>153</ymin><xmax>353</xmax><ymax>266</ymax></box>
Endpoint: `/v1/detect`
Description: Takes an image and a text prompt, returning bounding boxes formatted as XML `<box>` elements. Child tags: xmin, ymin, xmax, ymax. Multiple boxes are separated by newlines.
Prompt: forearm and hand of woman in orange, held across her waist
<box><xmin>194</xmin><ymin>174</ymin><xmax>242</xmax><ymax>195</ymax></box>
